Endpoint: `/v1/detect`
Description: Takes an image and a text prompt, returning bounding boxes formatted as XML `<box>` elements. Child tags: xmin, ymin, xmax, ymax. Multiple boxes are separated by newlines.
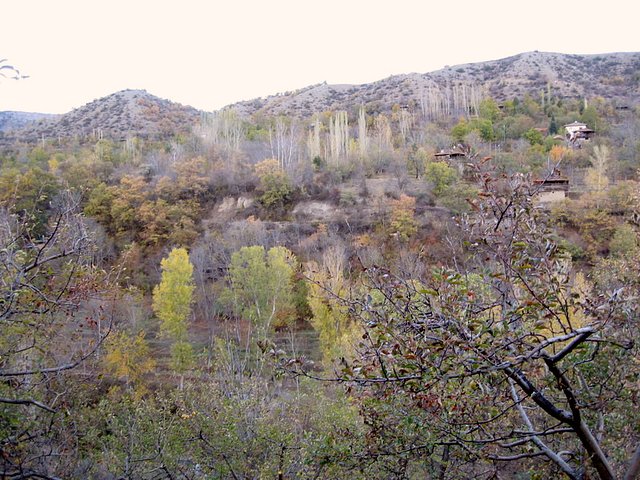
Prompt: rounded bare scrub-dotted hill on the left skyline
<box><xmin>4</xmin><ymin>90</ymin><xmax>200</xmax><ymax>142</ymax></box>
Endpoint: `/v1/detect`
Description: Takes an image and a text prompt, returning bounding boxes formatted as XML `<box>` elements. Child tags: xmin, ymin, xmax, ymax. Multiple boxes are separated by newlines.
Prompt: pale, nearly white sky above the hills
<box><xmin>0</xmin><ymin>0</ymin><xmax>640</xmax><ymax>113</ymax></box>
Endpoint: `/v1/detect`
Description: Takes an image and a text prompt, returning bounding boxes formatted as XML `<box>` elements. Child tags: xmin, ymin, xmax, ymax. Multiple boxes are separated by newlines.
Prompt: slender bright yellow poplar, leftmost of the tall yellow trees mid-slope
<box><xmin>153</xmin><ymin>248</ymin><xmax>195</xmax><ymax>389</ymax></box>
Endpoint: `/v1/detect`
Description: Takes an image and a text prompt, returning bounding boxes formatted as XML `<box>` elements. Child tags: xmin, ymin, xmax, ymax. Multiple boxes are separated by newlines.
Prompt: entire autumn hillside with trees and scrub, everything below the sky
<box><xmin>0</xmin><ymin>52</ymin><xmax>640</xmax><ymax>480</ymax></box>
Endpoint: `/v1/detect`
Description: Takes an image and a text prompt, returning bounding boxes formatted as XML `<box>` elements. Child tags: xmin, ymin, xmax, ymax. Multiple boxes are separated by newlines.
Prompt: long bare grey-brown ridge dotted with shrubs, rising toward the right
<box><xmin>232</xmin><ymin>52</ymin><xmax>640</xmax><ymax>117</ymax></box>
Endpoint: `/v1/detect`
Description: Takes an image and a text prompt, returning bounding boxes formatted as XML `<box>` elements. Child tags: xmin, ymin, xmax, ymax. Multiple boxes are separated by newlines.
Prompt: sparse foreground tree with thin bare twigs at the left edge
<box><xmin>0</xmin><ymin>194</ymin><xmax>112</xmax><ymax>479</ymax></box>
